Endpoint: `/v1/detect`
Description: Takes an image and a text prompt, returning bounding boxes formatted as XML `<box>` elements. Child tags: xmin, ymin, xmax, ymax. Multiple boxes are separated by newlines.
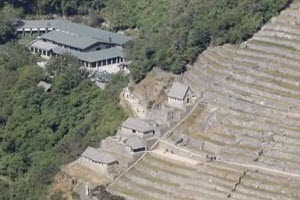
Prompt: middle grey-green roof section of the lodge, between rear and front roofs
<box><xmin>41</xmin><ymin>31</ymin><xmax>99</xmax><ymax>50</ymax></box>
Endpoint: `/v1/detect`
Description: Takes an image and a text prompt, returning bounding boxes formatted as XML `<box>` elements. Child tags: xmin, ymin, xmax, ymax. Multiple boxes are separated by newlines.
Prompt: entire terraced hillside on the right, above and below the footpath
<box><xmin>109</xmin><ymin>0</ymin><xmax>300</xmax><ymax>200</ymax></box>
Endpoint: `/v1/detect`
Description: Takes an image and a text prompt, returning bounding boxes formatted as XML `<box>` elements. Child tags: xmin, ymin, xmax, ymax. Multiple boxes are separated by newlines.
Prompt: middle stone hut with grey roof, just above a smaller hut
<box><xmin>121</xmin><ymin>117</ymin><xmax>155</xmax><ymax>139</ymax></box>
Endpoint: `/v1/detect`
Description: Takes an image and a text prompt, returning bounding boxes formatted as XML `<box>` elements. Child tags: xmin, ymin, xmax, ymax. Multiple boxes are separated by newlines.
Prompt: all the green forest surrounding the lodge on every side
<box><xmin>0</xmin><ymin>0</ymin><xmax>291</xmax><ymax>200</ymax></box>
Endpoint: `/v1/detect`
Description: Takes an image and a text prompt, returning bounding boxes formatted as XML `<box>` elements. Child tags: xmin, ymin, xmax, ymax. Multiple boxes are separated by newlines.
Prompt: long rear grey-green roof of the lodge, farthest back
<box><xmin>19</xmin><ymin>20</ymin><xmax>132</xmax><ymax>45</ymax></box>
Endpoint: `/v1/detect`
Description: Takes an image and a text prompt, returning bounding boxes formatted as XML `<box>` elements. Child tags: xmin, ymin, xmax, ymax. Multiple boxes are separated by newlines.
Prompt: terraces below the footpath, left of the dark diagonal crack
<box><xmin>109</xmin><ymin>154</ymin><xmax>242</xmax><ymax>199</ymax></box>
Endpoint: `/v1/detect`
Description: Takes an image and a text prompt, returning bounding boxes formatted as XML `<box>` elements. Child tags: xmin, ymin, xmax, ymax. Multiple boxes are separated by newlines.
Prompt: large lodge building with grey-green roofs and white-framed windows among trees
<box><xmin>17</xmin><ymin>20</ymin><xmax>131</xmax><ymax>68</ymax></box>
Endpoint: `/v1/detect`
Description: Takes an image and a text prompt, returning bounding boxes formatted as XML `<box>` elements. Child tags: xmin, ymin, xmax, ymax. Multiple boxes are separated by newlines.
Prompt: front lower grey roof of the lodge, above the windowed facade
<box><xmin>52</xmin><ymin>47</ymin><xmax>124</xmax><ymax>63</ymax></box>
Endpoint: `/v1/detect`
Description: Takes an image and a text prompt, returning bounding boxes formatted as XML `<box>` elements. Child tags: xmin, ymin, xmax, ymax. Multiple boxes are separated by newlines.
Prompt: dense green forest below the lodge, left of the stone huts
<box><xmin>0</xmin><ymin>44</ymin><xmax>127</xmax><ymax>200</ymax></box>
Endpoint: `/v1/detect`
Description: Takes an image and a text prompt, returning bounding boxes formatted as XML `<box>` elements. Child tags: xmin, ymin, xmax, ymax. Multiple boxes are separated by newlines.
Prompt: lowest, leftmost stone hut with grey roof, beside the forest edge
<box><xmin>78</xmin><ymin>147</ymin><xmax>118</xmax><ymax>177</ymax></box>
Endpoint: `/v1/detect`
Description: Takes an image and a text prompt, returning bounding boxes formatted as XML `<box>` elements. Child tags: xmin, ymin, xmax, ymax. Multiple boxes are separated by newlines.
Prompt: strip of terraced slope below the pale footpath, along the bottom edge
<box><xmin>109</xmin><ymin>154</ymin><xmax>300</xmax><ymax>200</ymax></box>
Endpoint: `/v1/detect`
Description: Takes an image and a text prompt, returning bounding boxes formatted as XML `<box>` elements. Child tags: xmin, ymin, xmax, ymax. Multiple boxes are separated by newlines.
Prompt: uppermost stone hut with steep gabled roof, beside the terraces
<box><xmin>168</xmin><ymin>82</ymin><xmax>193</xmax><ymax>109</ymax></box>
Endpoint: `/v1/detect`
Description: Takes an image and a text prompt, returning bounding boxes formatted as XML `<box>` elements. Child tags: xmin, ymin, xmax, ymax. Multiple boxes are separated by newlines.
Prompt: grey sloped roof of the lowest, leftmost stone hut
<box><xmin>81</xmin><ymin>147</ymin><xmax>117</xmax><ymax>164</ymax></box>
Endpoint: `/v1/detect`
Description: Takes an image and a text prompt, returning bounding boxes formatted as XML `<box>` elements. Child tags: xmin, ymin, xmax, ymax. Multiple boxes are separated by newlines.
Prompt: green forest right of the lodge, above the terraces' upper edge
<box><xmin>106</xmin><ymin>0</ymin><xmax>291</xmax><ymax>80</ymax></box>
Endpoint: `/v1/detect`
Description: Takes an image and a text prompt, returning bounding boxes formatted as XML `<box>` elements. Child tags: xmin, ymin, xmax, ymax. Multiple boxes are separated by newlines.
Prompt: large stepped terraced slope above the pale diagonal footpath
<box><xmin>182</xmin><ymin>1</ymin><xmax>300</xmax><ymax>174</ymax></box>
